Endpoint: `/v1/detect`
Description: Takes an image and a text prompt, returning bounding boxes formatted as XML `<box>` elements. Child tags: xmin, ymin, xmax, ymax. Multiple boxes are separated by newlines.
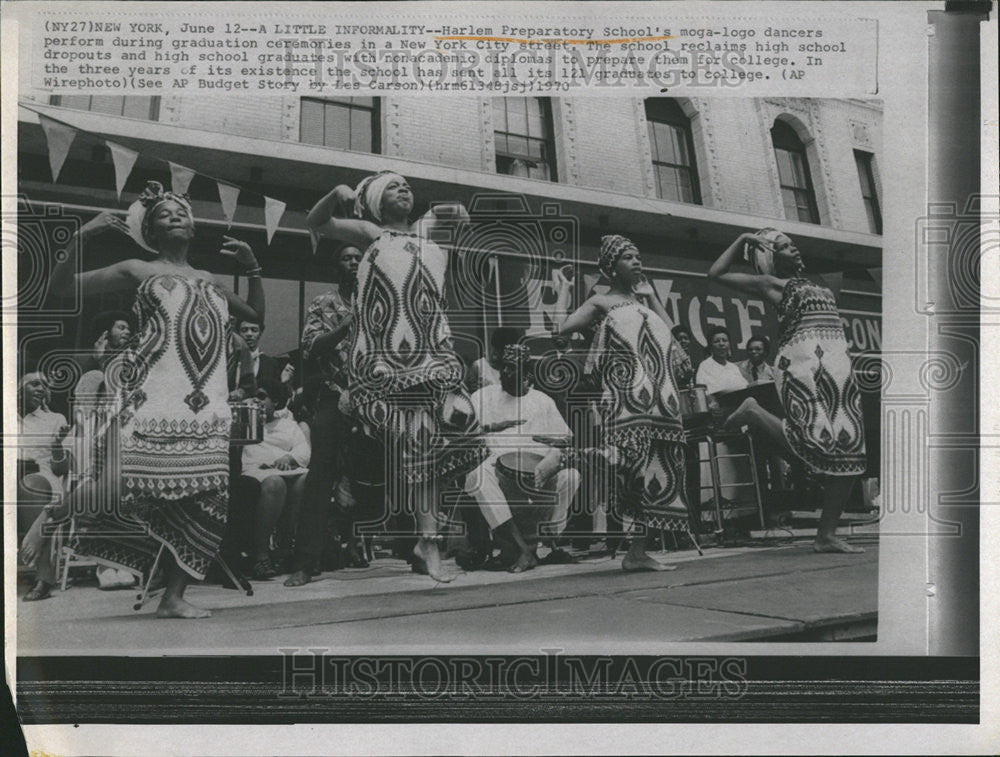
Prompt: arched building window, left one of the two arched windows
<box><xmin>645</xmin><ymin>97</ymin><xmax>701</xmax><ymax>205</ymax></box>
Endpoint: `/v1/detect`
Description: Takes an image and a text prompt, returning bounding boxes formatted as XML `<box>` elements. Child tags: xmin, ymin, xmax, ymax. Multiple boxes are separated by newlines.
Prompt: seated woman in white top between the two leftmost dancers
<box><xmin>240</xmin><ymin>384</ymin><xmax>311</xmax><ymax>579</ymax></box>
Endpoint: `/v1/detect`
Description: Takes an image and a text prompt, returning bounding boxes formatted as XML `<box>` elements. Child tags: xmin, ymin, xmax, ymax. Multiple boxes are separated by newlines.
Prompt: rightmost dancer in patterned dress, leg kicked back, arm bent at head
<box><xmin>708</xmin><ymin>229</ymin><xmax>865</xmax><ymax>552</ymax></box>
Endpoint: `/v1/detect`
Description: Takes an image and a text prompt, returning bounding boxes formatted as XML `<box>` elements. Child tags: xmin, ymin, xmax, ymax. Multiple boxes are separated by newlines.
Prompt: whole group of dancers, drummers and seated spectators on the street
<box><xmin>18</xmin><ymin>172</ymin><xmax>865</xmax><ymax>618</ymax></box>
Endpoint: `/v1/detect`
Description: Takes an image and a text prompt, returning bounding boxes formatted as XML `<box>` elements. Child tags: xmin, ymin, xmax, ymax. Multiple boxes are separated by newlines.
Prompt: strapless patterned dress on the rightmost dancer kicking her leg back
<box><xmin>774</xmin><ymin>278</ymin><xmax>866</xmax><ymax>476</ymax></box>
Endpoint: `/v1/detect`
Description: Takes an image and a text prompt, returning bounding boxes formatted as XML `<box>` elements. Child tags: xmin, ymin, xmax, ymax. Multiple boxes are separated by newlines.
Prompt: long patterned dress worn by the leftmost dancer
<box><xmin>80</xmin><ymin>274</ymin><xmax>231</xmax><ymax>579</ymax></box>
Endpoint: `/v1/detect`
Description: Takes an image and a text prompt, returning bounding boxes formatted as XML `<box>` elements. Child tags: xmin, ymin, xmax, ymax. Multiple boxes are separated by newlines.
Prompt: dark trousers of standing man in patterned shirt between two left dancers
<box><xmin>295</xmin><ymin>385</ymin><xmax>350</xmax><ymax>570</ymax></box>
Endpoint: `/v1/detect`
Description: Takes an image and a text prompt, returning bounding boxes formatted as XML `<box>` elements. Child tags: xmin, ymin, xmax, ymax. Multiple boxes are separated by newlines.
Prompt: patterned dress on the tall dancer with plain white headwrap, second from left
<box><xmin>348</xmin><ymin>230</ymin><xmax>488</xmax><ymax>483</ymax></box>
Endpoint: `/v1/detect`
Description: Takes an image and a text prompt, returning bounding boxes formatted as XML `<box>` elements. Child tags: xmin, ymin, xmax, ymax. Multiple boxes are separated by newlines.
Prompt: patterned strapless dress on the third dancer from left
<box><xmin>587</xmin><ymin>301</ymin><xmax>691</xmax><ymax>531</ymax></box>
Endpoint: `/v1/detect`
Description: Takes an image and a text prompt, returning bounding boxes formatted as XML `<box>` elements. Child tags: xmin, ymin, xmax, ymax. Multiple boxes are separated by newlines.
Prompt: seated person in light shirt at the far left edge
<box><xmin>17</xmin><ymin>373</ymin><xmax>71</xmax><ymax>602</ymax></box>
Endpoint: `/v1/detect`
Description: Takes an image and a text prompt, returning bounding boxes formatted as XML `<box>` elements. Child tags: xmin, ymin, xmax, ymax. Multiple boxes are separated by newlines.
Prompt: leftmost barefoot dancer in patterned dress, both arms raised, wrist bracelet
<box><xmin>52</xmin><ymin>182</ymin><xmax>264</xmax><ymax>618</ymax></box>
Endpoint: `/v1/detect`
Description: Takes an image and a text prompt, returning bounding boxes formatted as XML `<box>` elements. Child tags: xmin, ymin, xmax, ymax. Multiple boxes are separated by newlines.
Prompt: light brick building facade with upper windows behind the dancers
<box><xmin>18</xmin><ymin>91</ymin><xmax>882</xmax><ymax>364</ymax></box>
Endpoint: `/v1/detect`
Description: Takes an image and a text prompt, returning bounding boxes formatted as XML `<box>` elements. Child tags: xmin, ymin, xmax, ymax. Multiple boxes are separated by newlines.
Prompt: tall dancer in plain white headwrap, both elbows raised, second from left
<box><xmin>308</xmin><ymin>171</ymin><xmax>488</xmax><ymax>582</ymax></box>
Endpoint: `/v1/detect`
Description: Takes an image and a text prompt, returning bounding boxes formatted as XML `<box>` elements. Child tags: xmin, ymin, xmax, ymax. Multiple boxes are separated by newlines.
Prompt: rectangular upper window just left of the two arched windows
<box><xmin>493</xmin><ymin>97</ymin><xmax>557</xmax><ymax>181</ymax></box>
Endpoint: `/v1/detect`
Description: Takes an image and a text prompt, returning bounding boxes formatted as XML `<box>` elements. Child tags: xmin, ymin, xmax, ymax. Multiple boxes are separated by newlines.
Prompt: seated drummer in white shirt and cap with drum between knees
<box><xmin>465</xmin><ymin>344</ymin><xmax>580</xmax><ymax>573</ymax></box>
